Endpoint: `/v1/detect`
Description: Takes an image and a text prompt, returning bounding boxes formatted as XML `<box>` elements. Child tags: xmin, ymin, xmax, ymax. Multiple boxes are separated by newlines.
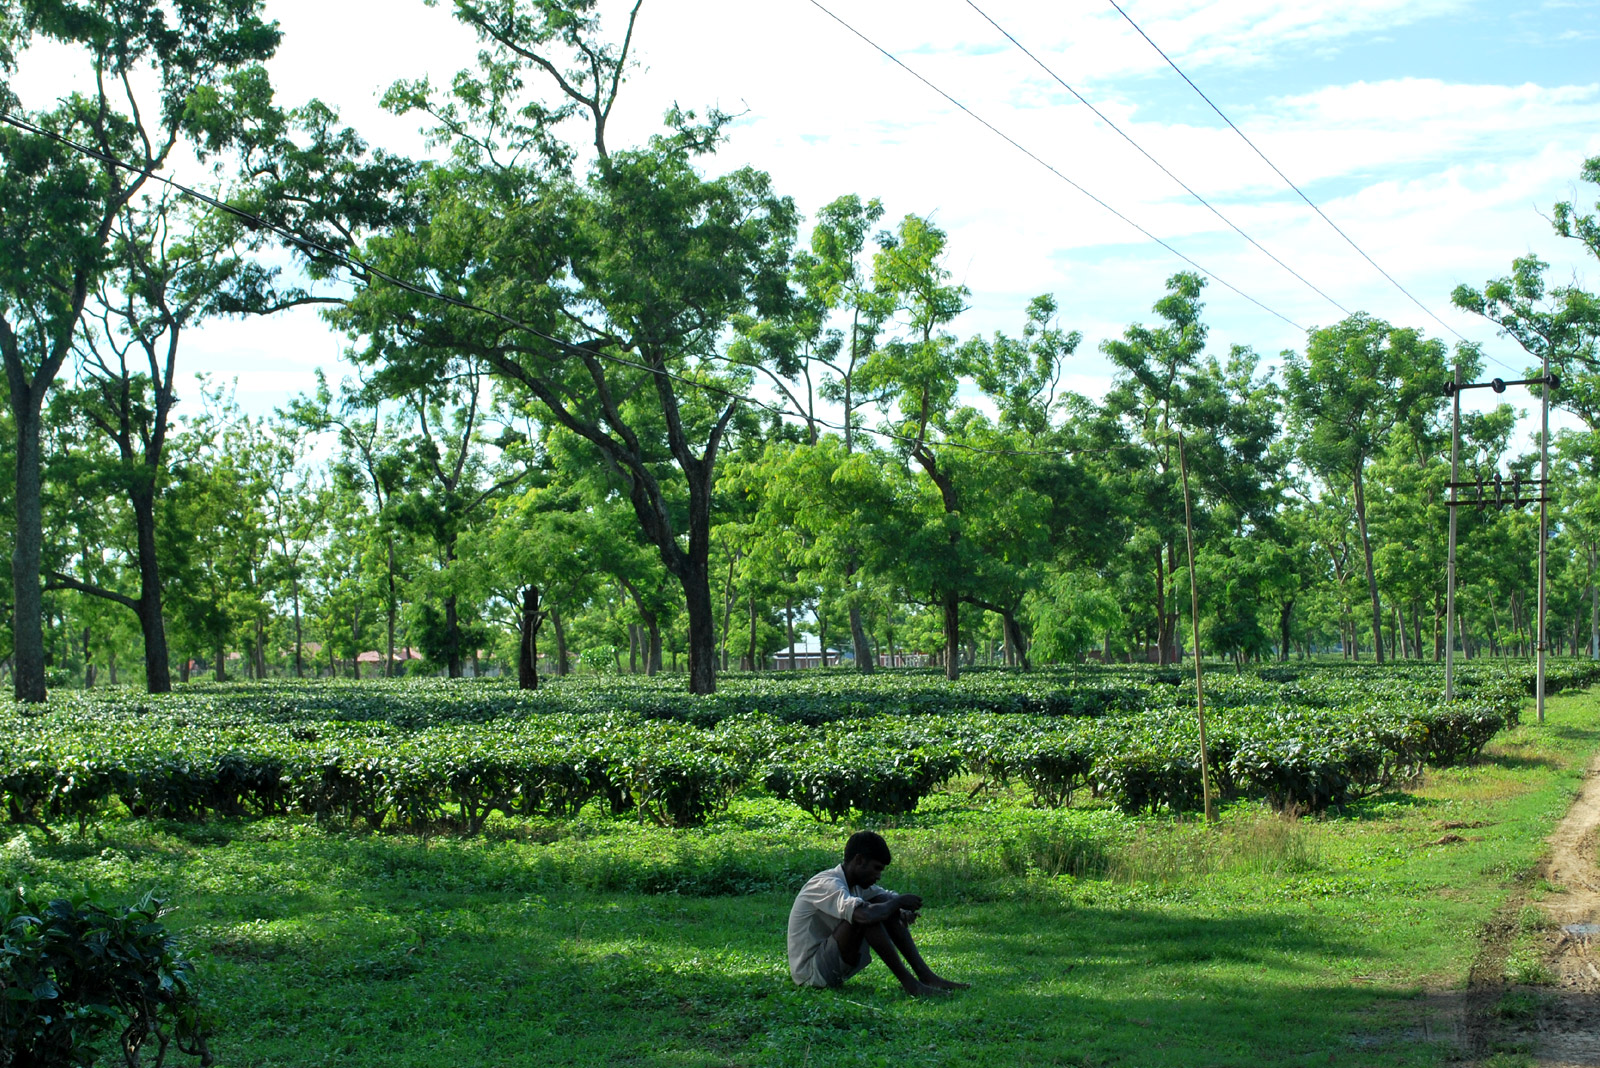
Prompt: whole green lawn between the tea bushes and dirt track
<box><xmin>9</xmin><ymin>694</ymin><xmax>1600</xmax><ymax>1068</ymax></box>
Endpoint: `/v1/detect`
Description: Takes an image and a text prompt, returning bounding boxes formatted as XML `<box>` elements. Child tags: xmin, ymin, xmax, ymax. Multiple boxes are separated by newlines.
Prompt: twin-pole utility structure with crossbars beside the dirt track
<box><xmin>1445</xmin><ymin>370</ymin><xmax>1562</xmax><ymax>723</ymax></box>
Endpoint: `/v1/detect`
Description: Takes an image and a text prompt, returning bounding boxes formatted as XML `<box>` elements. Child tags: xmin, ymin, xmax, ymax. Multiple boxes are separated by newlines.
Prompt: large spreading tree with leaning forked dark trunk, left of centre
<box><xmin>326</xmin><ymin>0</ymin><xmax>795</xmax><ymax>692</ymax></box>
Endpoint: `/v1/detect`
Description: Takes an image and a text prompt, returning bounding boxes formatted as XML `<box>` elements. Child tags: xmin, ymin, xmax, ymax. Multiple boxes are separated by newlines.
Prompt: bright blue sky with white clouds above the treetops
<box><xmin>13</xmin><ymin>0</ymin><xmax>1600</xmax><ymax>434</ymax></box>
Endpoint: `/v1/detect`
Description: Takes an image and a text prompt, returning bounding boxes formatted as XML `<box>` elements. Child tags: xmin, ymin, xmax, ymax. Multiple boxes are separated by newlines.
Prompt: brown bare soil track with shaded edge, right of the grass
<box><xmin>1461</xmin><ymin>755</ymin><xmax>1600</xmax><ymax>1068</ymax></box>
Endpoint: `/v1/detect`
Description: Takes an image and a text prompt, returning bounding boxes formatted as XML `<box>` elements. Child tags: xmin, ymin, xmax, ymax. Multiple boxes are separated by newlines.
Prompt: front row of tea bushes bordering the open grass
<box><xmin>0</xmin><ymin>661</ymin><xmax>1522</xmax><ymax>833</ymax></box>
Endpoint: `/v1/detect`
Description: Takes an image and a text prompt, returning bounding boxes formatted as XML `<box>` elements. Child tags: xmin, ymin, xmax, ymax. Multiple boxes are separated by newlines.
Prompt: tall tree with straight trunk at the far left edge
<box><xmin>0</xmin><ymin>0</ymin><xmax>278</xmax><ymax>702</ymax></box>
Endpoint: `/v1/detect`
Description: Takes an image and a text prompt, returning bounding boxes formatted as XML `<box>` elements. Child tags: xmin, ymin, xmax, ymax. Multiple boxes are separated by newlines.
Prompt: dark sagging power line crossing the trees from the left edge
<box><xmin>0</xmin><ymin>112</ymin><xmax>1094</xmax><ymax>457</ymax></box>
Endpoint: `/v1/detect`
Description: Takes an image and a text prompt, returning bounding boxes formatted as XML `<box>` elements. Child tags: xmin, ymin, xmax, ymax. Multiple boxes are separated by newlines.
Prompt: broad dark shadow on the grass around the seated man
<box><xmin>181</xmin><ymin>894</ymin><xmax>1420</xmax><ymax>1068</ymax></box>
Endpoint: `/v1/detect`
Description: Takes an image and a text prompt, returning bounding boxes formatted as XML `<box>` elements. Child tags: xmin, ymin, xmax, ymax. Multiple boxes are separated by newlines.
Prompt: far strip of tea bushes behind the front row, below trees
<box><xmin>24</xmin><ymin>660</ymin><xmax>1574</xmax><ymax>731</ymax></box>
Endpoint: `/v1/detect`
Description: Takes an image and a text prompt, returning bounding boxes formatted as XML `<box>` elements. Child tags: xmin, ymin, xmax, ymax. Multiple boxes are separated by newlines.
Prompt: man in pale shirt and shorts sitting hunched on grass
<box><xmin>789</xmin><ymin>831</ymin><xmax>968</xmax><ymax>998</ymax></box>
